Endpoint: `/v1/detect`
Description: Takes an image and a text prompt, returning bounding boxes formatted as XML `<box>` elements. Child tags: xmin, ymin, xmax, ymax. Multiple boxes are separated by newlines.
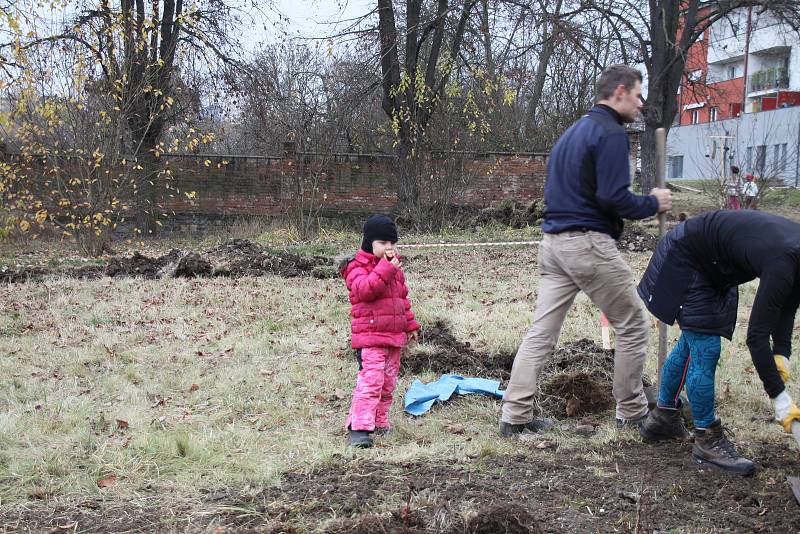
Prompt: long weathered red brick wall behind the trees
<box><xmin>159</xmin><ymin>151</ymin><xmax>546</xmax><ymax>224</ymax></box>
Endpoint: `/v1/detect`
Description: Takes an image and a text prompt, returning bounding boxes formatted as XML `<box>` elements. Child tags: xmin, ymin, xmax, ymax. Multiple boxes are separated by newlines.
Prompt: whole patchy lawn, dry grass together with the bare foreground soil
<box><xmin>0</xmin><ymin>219</ymin><xmax>800</xmax><ymax>533</ymax></box>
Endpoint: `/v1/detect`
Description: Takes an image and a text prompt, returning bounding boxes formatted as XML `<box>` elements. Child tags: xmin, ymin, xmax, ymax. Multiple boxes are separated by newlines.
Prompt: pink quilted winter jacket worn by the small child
<box><xmin>342</xmin><ymin>250</ymin><xmax>419</xmax><ymax>349</ymax></box>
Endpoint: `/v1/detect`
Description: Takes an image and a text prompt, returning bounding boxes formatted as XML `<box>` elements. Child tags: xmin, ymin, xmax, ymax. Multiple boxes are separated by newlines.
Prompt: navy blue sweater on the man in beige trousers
<box><xmin>542</xmin><ymin>104</ymin><xmax>658</xmax><ymax>239</ymax></box>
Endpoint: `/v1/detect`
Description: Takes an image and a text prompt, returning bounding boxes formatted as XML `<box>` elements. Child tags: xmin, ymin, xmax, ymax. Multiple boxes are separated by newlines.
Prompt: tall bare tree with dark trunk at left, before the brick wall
<box><xmin>3</xmin><ymin>0</ymin><xmax>256</xmax><ymax>232</ymax></box>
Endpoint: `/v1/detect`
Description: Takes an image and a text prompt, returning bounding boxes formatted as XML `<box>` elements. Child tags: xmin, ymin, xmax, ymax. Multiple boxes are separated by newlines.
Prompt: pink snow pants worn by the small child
<box><xmin>347</xmin><ymin>347</ymin><xmax>400</xmax><ymax>431</ymax></box>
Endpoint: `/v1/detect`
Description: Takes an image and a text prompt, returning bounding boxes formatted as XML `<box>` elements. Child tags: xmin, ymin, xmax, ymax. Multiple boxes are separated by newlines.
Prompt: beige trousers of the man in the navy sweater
<box><xmin>502</xmin><ymin>232</ymin><xmax>650</xmax><ymax>424</ymax></box>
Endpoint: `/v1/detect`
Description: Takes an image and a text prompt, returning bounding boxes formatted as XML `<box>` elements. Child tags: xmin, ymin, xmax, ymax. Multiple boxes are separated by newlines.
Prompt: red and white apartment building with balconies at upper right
<box><xmin>667</xmin><ymin>4</ymin><xmax>800</xmax><ymax>185</ymax></box>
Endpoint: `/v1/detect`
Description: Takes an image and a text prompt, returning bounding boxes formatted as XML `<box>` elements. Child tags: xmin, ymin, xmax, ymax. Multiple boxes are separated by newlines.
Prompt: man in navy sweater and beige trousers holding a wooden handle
<box><xmin>500</xmin><ymin>65</ymin><xmax>672</xmax><ymax>437</ymax></box>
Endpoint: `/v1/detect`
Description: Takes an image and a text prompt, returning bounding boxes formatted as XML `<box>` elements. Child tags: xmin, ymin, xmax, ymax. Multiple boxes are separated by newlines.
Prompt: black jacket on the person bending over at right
<box><xmin>638</xmin><ymin>210</ymin><xmax>800</xmax><ymax>399</ymax></box>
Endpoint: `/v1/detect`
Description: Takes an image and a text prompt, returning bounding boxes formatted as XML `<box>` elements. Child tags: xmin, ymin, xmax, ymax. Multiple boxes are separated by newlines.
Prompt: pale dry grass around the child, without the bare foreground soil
<box><xmin>0</xmin><ymin>211</ymin><xmax>800</xmax><ymax>532</ymax></box>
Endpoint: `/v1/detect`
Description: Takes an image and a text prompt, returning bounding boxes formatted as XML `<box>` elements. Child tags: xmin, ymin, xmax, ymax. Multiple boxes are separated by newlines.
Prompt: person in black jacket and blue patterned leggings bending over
<box><xmin>638</xmin><ymin>211</ymin><xmax>800</xmax><ymax>475</ymax></box>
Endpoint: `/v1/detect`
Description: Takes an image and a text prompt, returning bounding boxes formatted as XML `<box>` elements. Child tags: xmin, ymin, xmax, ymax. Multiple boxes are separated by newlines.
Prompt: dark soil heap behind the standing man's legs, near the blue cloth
<box><xmin>400</xmin><ymin>320</ymin><xmax>650</xmax><ymax>418</ymax></box>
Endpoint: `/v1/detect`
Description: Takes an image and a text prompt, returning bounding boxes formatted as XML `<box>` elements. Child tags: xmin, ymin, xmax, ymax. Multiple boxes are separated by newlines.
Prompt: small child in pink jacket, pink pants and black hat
<box><xmin>340</xmin><ymin>215</ymin><xmax>419</xmax><ymax>447</ymax></box>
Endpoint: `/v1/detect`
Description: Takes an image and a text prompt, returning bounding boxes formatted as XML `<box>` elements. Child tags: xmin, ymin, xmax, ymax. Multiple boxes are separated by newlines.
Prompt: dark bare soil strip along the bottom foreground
<box><xmin>0</xmin><ymin>442</ymin><xmax>800</xmax><ymax>534</ymax></box>
